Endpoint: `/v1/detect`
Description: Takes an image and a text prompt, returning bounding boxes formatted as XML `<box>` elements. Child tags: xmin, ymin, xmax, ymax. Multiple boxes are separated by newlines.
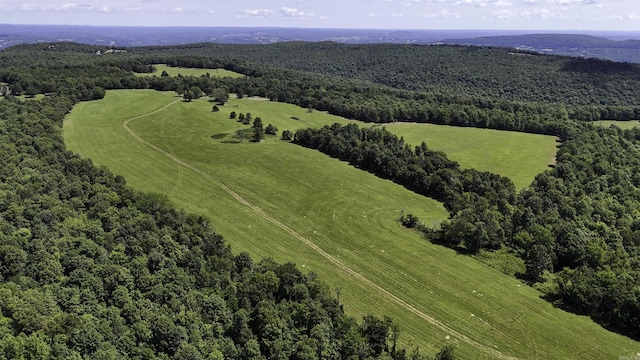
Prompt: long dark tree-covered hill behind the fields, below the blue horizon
<box><xmin>132</xmin><ymin>42</ymin><xmax>640</xmax><ymax>106</ymax></box>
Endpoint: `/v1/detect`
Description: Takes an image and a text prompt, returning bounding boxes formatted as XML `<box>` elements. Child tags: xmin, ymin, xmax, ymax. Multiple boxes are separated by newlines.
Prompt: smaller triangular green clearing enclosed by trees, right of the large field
<box><xmin>387</xmin><ymin>123</ymin><xmax>556</xmax><ymax>190</ymax></box>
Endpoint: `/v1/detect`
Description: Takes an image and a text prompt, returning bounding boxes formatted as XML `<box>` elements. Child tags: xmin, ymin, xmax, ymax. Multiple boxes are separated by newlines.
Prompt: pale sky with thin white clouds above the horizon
<box><xmin>0</xmin><ymin>0</ymin><xmax>640</xmax><ymax>31</ymax></box>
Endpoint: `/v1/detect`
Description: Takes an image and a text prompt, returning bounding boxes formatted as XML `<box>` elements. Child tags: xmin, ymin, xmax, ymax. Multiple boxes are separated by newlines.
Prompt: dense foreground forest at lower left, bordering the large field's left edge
<box><xmin>0</xmin><ymin>95</ymin><xmax>451</xmax><ymax>360</ymax></box>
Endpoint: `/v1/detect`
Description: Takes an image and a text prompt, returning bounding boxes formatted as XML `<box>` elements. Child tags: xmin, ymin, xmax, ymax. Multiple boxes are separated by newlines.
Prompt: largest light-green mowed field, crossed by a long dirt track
<box><xmin>64</xmin><ymin>90</ymin><xmax>640</xmax><ymax>359</ymax></box>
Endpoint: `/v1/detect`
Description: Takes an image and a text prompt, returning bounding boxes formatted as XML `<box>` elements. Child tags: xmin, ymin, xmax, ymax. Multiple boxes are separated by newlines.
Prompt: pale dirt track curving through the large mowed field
<box><xmin>122</xmin><ymin>100</ymin><xmax>517</xmax><ymax>360</ymax></box>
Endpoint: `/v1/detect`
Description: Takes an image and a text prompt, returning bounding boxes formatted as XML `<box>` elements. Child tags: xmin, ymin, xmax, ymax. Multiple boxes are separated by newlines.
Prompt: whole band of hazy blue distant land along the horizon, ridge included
<box><xmin>0</xmin><ymin>24</ymin><xmax>640</xmax><ymax>63</ymax></box>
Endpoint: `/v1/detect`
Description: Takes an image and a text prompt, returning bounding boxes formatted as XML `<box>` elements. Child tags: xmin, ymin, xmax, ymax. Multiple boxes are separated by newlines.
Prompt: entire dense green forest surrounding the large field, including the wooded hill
<box><xmin>0</xmin><ymin>39</ymin><xmax>640</xmax><ymax>348</ymax></box>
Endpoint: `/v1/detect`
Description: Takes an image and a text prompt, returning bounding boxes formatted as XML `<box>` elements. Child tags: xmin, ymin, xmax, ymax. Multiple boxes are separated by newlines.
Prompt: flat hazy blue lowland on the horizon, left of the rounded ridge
<box><xmin>0</xmin><ymin>24</ymin><xmax>498</xmax><ymax>49</ymax></box>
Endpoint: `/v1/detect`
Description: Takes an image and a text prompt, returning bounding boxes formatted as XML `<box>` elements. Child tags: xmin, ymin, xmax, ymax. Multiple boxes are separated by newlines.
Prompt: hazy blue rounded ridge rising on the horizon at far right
<box><xmin>442</xmin><ymin>34</ymin><xmax>640</xmax><ymax>63</ymax></box>
